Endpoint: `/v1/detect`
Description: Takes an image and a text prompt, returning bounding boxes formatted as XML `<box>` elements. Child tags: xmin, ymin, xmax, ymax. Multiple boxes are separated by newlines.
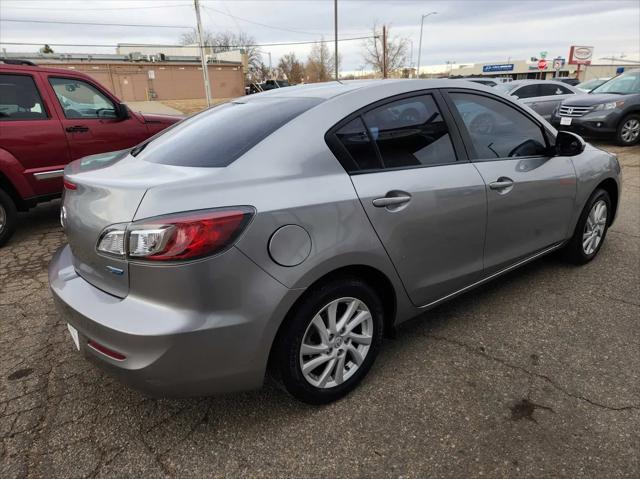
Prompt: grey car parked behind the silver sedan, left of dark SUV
<box><xmin>496</xmin><ymin>80</ymin><xmax>584</xmax><ymax>120</ymax></box>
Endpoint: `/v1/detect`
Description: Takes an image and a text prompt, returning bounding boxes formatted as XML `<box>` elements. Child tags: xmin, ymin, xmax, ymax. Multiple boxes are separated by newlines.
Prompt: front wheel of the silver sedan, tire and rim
<box><xmin>565</xmin><ymin>189</ymin><xmax>612</xmax><ymax>264</ymax></box>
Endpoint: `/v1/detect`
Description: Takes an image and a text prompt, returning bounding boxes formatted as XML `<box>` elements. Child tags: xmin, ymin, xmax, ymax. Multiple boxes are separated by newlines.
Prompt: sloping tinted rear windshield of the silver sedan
<box><xmin>138</xmin><ymin>98</ymin><xmax>322</xmax><ymax>167</ymax></box>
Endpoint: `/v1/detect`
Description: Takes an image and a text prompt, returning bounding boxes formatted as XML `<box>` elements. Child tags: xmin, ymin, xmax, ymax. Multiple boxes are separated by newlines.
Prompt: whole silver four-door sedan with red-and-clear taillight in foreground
<box><xmin>49</xmin><ymin>80</ymin><xmax>620</xmax><ymax>404</ymax></box>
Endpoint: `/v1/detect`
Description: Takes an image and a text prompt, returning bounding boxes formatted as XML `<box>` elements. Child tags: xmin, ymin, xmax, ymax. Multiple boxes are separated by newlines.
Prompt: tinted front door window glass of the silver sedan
<box><xmin>450</xmin><ymin>93</ymin><xmax>546</xmax><ymax>160</ymax></box>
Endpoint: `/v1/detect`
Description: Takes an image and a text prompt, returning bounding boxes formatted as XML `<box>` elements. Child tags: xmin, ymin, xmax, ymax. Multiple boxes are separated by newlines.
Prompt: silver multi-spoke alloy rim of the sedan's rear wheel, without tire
<box><xmin>300</xmin><ymin>297</ymin><xmax>374</xmax><ymax>389</ymax></box>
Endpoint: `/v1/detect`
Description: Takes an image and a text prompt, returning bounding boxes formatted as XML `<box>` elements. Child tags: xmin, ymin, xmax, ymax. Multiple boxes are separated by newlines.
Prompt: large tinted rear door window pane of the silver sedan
<box><xmin>363</xmin><ymin>95</ymin><xmax>456</xmax><ymax>168</ymax></box>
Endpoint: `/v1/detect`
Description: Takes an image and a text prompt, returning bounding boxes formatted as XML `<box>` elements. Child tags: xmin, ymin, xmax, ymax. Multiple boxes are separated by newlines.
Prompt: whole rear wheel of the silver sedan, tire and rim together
<box><xmin>274</xmin><ymin>278</ymin><xmax>383</xmax><ymax>404</ymax></box>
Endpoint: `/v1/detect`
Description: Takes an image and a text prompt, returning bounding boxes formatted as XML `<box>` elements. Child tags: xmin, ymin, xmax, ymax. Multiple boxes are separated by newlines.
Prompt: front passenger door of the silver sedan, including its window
<box><xmin>446</xmin><ymin>90</ymin><xmax>576</xmax><ymax>275</ymax></box>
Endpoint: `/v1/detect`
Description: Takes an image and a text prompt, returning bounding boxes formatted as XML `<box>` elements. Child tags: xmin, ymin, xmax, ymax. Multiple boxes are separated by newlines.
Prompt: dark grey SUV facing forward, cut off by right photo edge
<box><xmin>551</xmin><ymin>70</ymin><xmax>640</xmax><ymax>146</ymax></box>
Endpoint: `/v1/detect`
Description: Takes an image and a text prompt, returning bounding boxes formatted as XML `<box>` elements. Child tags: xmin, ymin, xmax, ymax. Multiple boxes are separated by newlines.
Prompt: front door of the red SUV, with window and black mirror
<box><xmin>48</xmin><ymin>75</ymin><xmax>148</xmax><ymax>160</ymax></box>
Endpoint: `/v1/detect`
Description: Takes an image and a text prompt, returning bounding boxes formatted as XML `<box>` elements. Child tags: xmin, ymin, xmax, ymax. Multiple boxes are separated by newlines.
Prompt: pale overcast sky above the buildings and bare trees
<box><xmin>0</xmin><ymin>0</ymin><xmax>640</xmax><ymax>71</ymax></box>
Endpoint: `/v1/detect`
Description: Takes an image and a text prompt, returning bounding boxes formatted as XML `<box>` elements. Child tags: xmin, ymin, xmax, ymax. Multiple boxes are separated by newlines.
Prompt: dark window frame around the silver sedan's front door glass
<box><xmin>442</xmin><ymin>88</ymin><xmax>556</xmax><ymax>163</ymax></box>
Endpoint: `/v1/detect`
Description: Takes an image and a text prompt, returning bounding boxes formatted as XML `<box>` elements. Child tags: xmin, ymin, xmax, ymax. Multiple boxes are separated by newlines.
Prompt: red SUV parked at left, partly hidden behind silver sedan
<box><xmin>0</xmin><ymin>60</ymin><xmax>180</xmax><ymax>246</ymax></box>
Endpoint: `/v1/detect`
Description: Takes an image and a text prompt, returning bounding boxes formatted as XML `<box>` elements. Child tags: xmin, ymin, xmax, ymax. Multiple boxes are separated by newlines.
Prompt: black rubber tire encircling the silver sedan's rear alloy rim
<box><xmin>272</xmin><ymin>277</ymin><xmax>384</xmax><ymax>404</ymax></box>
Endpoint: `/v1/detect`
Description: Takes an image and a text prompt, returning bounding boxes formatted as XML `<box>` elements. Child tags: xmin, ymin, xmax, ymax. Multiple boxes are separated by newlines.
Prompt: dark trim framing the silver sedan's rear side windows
<box><xmin>324</xmin><ymin>88</ymin><xmax>469</xmax><ymax>175</ymax></box>
